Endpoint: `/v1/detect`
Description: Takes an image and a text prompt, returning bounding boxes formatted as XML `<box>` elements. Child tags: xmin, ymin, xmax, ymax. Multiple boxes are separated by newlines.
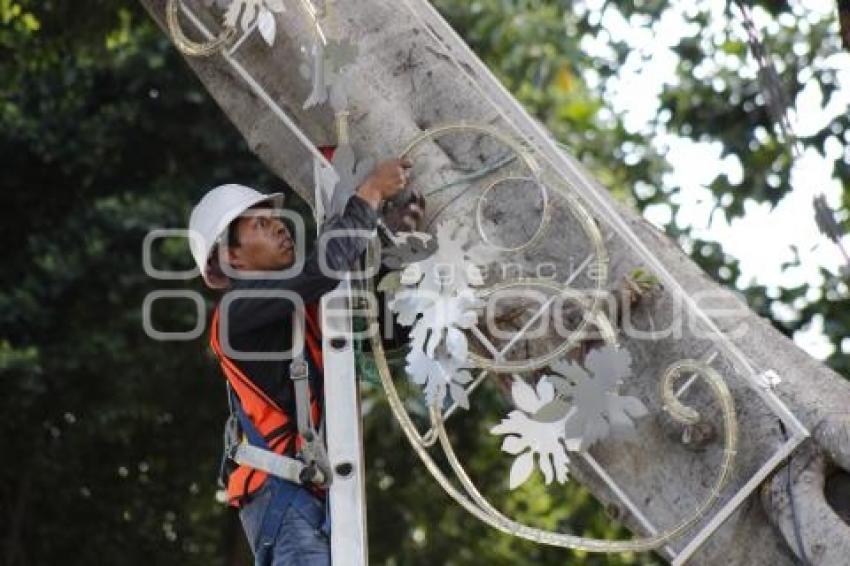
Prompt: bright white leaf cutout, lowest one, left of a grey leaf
<box><xmin>490</xmin><ymin>376</ymin><xmax>570</xmax><ymax>489</ymax></box>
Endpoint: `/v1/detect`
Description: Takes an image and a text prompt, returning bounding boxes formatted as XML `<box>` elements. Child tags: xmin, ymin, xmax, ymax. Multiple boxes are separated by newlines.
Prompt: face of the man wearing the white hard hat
<box><xmin>227</xmin><ymin>208</ymin><xmax>295</xmax><ymax>271</ymax></box>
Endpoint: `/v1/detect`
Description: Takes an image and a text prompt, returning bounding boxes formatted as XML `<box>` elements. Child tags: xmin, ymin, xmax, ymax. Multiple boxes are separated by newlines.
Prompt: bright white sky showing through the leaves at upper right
<box><xmin>583</xmin><ymin>0</ymin><xmax>850</xmax><ymax>359</ymax></box>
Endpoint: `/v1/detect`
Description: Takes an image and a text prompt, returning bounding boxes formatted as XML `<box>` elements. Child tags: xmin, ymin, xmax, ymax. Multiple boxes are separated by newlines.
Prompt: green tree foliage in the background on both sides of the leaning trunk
<box><xmin>0</xmin><ymin>0</ymin><xmax>850</xmax><ymax>566</ymax></box>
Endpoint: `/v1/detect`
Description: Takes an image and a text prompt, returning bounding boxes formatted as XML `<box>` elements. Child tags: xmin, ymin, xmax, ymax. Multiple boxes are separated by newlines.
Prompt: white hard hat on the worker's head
<box><xmin>189</xmin><ymin>184</ymin><xmax>283</xmax><ymax>287</ymax></box>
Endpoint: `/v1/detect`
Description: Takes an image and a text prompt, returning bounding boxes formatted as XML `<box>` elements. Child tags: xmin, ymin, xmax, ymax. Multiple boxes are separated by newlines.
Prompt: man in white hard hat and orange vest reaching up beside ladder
<box><xmin>189</xmin><ymin>160</ymin><xmax>422</xmax><ymax>566</ymax></box>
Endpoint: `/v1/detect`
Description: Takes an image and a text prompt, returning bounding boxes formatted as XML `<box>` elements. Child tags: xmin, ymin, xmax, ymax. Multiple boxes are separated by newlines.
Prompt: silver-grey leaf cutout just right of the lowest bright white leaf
<box><xmin>536</xmin><ymin>346</ymin><xmax>649</xmax><ymax>450</ymax></box>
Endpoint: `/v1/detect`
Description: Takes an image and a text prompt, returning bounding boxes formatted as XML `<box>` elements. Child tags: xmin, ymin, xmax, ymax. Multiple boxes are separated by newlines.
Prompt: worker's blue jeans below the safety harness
<box><xmin>239</xmin><ymin>481</ymin><xmax>331</xmax><ymax>566</ymax></box>
